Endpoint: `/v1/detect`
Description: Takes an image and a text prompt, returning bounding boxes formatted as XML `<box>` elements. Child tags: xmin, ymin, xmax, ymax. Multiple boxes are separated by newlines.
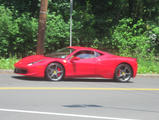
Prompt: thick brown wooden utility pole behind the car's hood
<box><xmin>36</xmin><ymin>0</ymin><xmax>48</xmax><ymax>55</ymax></box>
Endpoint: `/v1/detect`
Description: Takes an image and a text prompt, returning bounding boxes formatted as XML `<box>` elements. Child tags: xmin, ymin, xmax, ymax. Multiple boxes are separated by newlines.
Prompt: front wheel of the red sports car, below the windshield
<box><xmin>45</xmin><ymin>62</ymin><xmax>65</xmax><ymax>81</ymax></box>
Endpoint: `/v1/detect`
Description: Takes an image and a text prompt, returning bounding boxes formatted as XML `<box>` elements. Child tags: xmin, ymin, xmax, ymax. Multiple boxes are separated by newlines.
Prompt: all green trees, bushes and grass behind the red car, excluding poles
<box><xmin>0</xmin><ymin>0</ymin><xmax>159</xmax><ymax>73</ymax></box>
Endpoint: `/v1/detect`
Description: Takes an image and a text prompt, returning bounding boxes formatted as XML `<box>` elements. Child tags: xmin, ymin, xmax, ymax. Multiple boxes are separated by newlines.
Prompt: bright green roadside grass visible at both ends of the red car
<box><xmin>0</xmin><ymin>57</ymin><xmax>159</xmax><ymax>74</ymax></box>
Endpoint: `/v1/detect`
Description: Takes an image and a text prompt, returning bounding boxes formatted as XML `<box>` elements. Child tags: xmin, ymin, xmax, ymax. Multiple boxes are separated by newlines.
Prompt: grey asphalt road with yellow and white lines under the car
<box><xmin>0</xmin><ymin>73</ymin><xmax>159</xmax><ymax>120</ymax></box>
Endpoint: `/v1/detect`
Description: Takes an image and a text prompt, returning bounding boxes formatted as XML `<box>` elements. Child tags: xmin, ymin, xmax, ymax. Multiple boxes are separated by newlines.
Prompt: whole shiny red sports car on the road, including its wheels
<box><xmin>14</xmin><ymin>46</ymin><xmax>137</xmax><ymax>82</ymax></box>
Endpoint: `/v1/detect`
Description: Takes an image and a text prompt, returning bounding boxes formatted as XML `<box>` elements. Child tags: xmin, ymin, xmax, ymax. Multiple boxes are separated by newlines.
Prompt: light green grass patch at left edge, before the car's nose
<box><xmin>0</xmin><ymin>57</ymin><xmax>18</xmax><ymax>69</ymax></box>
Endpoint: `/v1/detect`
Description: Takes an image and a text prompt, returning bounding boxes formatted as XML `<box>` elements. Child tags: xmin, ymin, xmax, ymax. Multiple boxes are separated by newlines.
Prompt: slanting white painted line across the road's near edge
<box><xmin>0</xmin><ymin>108</ymin><xmax>137</xmax><ymax>120</ymax></box>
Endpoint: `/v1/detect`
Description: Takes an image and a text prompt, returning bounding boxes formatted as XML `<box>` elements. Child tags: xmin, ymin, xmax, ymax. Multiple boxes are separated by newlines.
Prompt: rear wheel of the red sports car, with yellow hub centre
<box><xmin>114</xmin><ymin>63</ymin><xmax>133</xmax><ymax>82</ymax></box>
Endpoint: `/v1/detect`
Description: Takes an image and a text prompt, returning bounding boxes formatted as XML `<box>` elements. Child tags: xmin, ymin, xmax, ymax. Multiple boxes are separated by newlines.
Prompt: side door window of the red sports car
<box><xmin>74</xmin><ymin>50</ymin><xmax>96</xmax><ymax>59</ymax></box>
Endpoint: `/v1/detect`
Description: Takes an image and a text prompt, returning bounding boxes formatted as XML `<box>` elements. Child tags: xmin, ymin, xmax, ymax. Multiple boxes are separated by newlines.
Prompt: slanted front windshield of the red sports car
<box><xmin>46</xmin><ymin>48</ymin><xmax>75</xmax><ymax>58</ymax></box>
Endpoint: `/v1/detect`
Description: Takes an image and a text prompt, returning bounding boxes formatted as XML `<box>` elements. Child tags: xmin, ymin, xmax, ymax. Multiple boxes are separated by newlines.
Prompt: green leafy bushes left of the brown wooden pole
<box><xmin>0</xmin><ymin>6</ymin><xmax>37</xmax><ymax>57</ymax></box>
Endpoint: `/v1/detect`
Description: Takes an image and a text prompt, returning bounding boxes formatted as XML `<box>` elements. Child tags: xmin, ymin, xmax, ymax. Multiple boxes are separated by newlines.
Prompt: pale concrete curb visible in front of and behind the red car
<box><xmin>0</xmin><ymin>69</ymin><xmax>159</xmax><ymax>77</ymax></box>
